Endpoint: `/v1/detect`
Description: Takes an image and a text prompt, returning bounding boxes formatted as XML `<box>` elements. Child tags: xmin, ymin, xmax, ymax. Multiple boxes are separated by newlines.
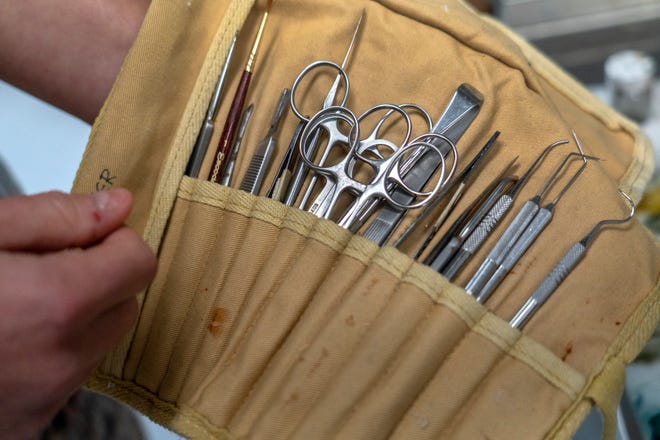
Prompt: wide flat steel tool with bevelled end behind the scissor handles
<box><xmin>364</xmin><ymin>84</ymin><xmax>483</xmax><ymax>246</ymax></box>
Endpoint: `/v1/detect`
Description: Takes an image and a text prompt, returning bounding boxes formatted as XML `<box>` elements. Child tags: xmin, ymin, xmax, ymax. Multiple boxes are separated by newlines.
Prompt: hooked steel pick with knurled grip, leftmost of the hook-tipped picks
<box><xmin>434</xmin><ymin>140</ymin><xmax>568</xmax><ymax>280</ymax></box>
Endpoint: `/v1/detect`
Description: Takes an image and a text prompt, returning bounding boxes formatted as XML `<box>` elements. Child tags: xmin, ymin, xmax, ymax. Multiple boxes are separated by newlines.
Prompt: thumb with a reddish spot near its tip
<box><xmin>0</xmin><ymin>189</ymin><xmax>133</xmax><ymax>252</ymax></box>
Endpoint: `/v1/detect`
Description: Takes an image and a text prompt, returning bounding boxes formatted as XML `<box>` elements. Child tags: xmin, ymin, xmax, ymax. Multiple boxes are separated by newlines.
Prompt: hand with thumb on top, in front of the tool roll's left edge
<box><xmin>0</xmin><ymin>189</ymin><xmax>156</xmax><ymax>439</ymax></box>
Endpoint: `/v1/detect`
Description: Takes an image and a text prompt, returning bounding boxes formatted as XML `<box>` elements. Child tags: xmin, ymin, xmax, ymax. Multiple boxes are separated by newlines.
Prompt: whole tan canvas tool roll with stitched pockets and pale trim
<box><xmin>74</xmin><ymin>0</ymin><xmax>660</xmax><ymax>439</ymax></box>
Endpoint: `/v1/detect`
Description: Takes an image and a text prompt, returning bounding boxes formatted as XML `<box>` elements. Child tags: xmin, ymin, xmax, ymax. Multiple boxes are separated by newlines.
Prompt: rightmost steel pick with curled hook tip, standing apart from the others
<box><xmin>509</xmin><ymin>190</ymin><xmax>635</xmax><ymax>329</ymax></box>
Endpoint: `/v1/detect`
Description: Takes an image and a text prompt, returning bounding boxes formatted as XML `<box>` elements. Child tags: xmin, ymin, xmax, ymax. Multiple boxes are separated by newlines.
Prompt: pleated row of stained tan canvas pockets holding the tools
<box><xmin>114</xmin><ymin>178</ymin><xmax>585</xmax><ymax>438</ymax></box>
